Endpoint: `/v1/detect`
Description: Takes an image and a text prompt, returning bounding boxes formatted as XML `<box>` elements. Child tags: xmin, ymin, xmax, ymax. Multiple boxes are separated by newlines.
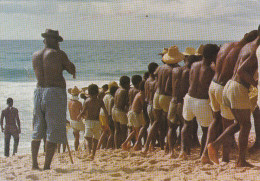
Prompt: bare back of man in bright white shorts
<box><xmin>188</xmin><ymin>61</ymin><xmax>215</xmax><ymax>99</ymax></box>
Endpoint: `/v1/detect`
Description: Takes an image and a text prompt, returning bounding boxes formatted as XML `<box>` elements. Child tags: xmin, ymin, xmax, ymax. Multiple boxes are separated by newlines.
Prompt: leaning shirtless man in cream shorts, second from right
<box><xmin>201</xmin><ymin>30</ymin><xmax>257</xmax><ymax>163</ymax></box>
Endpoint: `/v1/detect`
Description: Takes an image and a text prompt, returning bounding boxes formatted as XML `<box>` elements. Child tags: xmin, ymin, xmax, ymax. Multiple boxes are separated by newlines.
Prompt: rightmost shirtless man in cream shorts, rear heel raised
<box><xmin>208</xmin><ymin>30</ymin><xmax>260</xmax><ymax>167</ymax></box>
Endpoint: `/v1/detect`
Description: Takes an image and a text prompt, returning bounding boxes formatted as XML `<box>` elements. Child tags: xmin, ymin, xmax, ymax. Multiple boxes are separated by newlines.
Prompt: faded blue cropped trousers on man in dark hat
<box><xmin>32</xmin><ymin>87</ymin><xmax>67</xmax><ymax>144</ymax></box>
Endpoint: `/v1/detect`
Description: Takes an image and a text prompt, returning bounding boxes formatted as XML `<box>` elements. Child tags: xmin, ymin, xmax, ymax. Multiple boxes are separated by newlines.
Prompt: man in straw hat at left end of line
<box><xmin>68</xmin><ymin>86</ymin><xmax>85</xmax><ymax>151</ymax></box>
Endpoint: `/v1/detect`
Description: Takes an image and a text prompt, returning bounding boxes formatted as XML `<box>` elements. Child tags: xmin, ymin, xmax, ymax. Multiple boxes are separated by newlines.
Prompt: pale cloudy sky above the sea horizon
<box><xmin>0</xmin><ymin>0</ymin><xmax>260</xmax><ymax>40</ymax></box>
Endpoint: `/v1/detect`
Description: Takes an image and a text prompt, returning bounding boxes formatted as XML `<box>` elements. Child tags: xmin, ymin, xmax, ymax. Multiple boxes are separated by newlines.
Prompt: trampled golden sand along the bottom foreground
<box><xmin>0</xmin><ymin>134</ymin><xmax>260</xmax><ymax>181</ymax></box>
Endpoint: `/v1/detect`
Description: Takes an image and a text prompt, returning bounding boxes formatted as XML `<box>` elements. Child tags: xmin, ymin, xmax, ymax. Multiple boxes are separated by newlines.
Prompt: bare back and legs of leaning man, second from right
<box><xmin>201</xmin><ymin>32</ymin><xmax>256</xmax><ymax>163</ymax></box>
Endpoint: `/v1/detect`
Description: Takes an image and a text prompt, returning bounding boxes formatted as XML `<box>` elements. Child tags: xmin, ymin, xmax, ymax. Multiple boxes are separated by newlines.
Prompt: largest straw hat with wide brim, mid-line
<box><xmin>162</xmin><ymin>45</ymin><xmax>184</xmax><ymax>64</ymax></box>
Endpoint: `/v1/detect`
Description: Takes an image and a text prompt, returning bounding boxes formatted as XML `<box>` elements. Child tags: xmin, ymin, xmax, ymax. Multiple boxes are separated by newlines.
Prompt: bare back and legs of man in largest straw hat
<box><xmin>143</xmin><ymin>64</ymin><xmax>179</xmax><ymax>154</ymax></box>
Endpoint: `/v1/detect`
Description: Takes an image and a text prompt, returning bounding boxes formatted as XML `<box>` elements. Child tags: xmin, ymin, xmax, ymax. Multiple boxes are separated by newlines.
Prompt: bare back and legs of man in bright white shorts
<box><xmin>179</xmin><ymin>56</ymin><xmax>216</xmax><ymax>159</ymax></box>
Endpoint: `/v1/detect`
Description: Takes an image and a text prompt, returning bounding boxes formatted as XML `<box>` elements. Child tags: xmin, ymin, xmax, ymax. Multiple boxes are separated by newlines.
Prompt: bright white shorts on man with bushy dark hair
<box><xmin>183</xmin><ymin>94</ymin><xmax>213</xmax><ymax>127</ymax></box>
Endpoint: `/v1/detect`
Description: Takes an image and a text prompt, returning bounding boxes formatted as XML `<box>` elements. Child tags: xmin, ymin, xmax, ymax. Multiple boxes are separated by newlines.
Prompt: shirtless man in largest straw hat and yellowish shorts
<box><xmin>143</xmin><ymin>46</ymin><xmax>184</xmax><ymax>153</ymax></box>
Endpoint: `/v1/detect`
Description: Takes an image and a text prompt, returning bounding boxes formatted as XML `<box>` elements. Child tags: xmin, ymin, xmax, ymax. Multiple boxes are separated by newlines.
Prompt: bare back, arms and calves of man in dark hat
<box><xmin>31</xmin><ymin>37</ymin><xmax>76</xmax><ymax>170</ymax></box>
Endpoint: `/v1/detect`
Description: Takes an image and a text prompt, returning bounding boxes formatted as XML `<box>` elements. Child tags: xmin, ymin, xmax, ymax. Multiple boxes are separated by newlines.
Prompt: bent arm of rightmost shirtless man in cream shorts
<box><xmin>237</xmin><ymin>53</ymin><xmax>258</xmax><ymax>87</ymax></box>
